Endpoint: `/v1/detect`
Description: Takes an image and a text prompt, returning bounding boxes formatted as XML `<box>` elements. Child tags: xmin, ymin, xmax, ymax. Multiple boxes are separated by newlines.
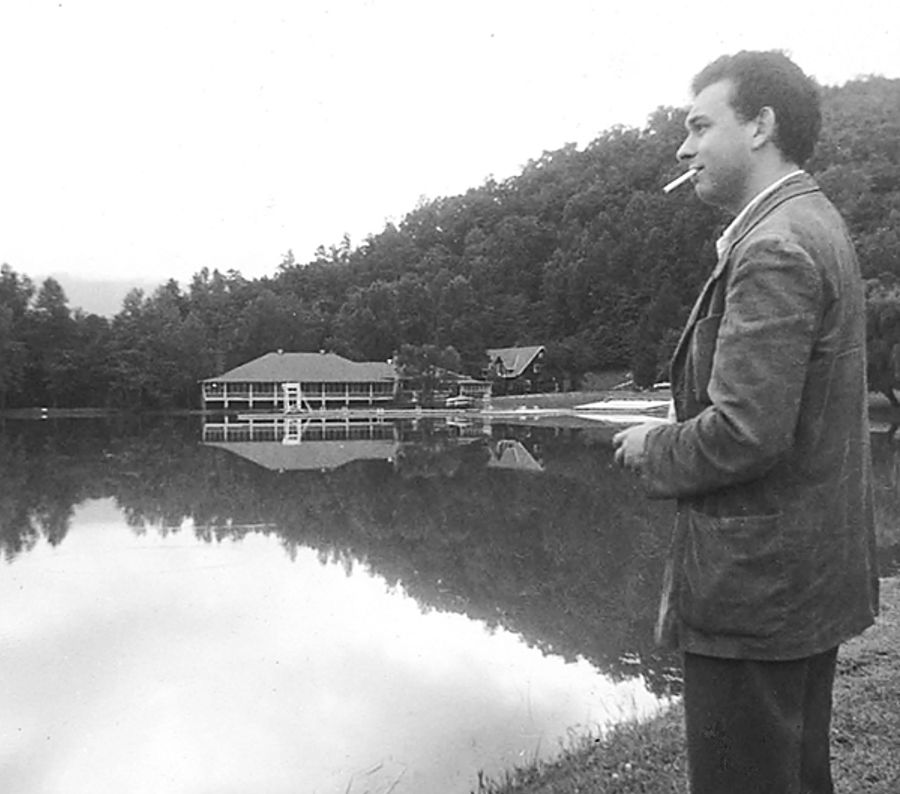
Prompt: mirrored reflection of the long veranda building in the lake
<box><xmin>203</xmin><ymin>417</ymin><xmax>400</xmax><ymax>471</ymax></box>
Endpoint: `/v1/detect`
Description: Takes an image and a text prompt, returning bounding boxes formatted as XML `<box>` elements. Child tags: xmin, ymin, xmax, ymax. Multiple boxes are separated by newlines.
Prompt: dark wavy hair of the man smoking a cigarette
<box><xmin>691</xmin><ymin>50</ymin><xmax>822</xmax><ymax>165</ymax></box>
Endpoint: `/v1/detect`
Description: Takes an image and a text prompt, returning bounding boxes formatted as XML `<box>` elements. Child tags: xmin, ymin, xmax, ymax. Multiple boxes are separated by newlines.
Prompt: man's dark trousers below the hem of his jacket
<box><xmin>684</xmin><ymin>648</ymin><xmax>837</xmax><ymax>794</ymax></box>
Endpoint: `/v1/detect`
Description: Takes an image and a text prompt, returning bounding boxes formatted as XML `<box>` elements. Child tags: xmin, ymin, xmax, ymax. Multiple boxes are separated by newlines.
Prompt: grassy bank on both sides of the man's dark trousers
<box><xmin>475</xmin><ymin>579</ymin><xmax>900</xmax><ymax>794</ymax></box>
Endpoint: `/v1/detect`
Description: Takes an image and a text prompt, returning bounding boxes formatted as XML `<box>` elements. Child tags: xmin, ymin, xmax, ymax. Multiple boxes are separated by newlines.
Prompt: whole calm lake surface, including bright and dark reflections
<box><xmin>0</xmin><ymin>417</ymin><xmax>900</xmax><ymax>794</ymax></box>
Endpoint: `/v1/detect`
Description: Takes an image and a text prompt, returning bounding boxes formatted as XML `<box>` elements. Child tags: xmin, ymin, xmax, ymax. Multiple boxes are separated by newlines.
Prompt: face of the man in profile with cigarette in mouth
<box><xmin>677</xmin><ymin>80</ymin><xmax>757</xmax><ymax>214</ymax></box>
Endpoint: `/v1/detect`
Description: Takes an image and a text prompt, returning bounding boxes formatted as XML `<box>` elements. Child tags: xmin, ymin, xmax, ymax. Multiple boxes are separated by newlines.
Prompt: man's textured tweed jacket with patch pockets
<box><xmin>642</xmin><ymin>172</ymin><xmax>878</xmax><ymax>660</ymax></box>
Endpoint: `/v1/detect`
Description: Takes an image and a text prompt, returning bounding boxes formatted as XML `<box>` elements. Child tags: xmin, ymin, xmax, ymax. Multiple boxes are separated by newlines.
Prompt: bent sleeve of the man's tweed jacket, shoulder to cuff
<box><xmin>643</xmin><ymin>232</ymin><xmax>824</xmax><ymax>498</ymax></box>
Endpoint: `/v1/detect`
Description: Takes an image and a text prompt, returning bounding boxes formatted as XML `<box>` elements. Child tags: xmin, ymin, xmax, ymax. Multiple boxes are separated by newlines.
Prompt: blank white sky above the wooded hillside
<box><xmin>0</xmin><ymin>0</ymin><xmax>900</xmax><ymax>281</ymax></box>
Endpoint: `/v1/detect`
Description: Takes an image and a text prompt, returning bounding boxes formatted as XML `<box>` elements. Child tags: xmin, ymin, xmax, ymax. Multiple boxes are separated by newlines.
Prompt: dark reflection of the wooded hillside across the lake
<box><xmin>0</xmin><ymin>420</ymin><xmax>900</xmax><ymax>692</ymax></box>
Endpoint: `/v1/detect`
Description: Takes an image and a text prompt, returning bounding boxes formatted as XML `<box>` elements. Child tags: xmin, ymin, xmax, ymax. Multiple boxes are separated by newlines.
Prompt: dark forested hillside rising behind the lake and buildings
<box><xmin>0</xmin><ymin>77</ymin><xmax>900</xmax><ymax>408</ymax></box>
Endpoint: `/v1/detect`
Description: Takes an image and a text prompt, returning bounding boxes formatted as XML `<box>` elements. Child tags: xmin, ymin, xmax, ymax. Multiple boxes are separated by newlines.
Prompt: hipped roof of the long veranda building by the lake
<box><xmin>209</xmin><ymin>353</ymin><xmax>396</xmax><ymax>383</ymax></box>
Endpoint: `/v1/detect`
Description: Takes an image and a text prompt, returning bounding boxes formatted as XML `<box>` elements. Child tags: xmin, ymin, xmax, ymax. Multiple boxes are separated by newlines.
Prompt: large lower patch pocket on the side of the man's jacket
<box><xmin>679</xmin><ymin>510</ymin><xmax>789</xmax><ymax>637</ymax></box>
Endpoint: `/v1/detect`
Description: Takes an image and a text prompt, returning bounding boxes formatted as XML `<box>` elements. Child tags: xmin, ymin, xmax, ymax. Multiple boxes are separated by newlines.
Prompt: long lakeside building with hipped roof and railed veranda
<box><xmin>202</xmin><ymin>351</ymin><xmax>397</xmax><ymax>410</ymax></box>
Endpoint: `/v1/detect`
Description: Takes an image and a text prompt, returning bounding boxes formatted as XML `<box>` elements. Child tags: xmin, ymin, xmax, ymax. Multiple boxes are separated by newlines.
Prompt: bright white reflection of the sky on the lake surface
<box><xmin>0</xmin><ymin>500</ymin><xmax>655</xmax><ymax>794</ymax></box>
